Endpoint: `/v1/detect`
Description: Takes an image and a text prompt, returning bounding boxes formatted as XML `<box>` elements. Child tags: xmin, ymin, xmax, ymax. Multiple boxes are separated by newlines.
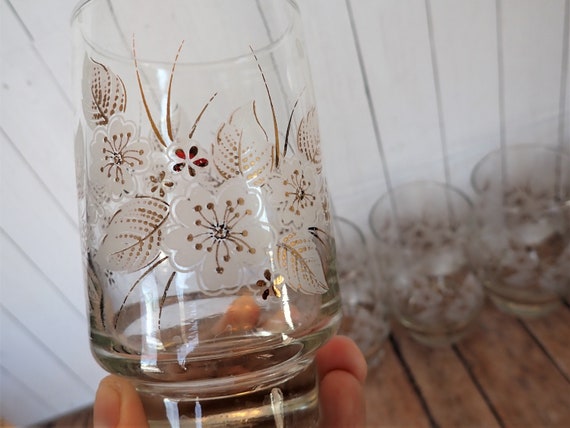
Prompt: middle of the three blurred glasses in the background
<box><xmin>370</xmin><ymin>181</ymin><xmax>484</xmax><ymax>346</ymax></box>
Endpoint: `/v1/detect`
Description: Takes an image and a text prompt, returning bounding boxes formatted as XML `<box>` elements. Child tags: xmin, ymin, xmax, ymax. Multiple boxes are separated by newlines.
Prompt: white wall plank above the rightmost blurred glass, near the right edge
<box><xmin>501</xmin><ymin>0</ymin><xmax>566</xmax><ymax>145</ymax></box>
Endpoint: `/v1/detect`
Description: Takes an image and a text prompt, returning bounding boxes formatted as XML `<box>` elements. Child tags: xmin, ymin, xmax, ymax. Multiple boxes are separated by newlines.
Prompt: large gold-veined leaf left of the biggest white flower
<box><xmin>96</xmin><ymin>197</ymin><xmax>169</xmax><ymax>272</ymax></box>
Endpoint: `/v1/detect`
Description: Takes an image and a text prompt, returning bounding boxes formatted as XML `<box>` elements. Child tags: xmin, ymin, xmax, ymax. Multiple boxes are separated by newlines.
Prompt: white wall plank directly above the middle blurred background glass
<box><xmin>350</xmin><ymin>0</ymin><xmax>445</xmax><ymax>189</ymax></box>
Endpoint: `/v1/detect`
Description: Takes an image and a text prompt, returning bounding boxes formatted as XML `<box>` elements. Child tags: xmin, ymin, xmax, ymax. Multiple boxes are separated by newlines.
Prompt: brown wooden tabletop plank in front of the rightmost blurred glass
<box><xmin>458</xmin><ymin>306</ymin><xmax>570</xmax><ymax>427</ymax></box>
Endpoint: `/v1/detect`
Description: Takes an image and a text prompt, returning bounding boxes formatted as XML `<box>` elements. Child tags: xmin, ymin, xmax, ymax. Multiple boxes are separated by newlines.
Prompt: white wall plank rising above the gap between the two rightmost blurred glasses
<box><xmin>428</xmin><ymin>0</ymin><xmax>500</xmax><ymax>191</ymax></box>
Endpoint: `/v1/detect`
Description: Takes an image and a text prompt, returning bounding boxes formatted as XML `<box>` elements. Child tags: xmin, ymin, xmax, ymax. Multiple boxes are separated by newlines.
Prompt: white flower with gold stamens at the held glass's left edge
<box><xmin>90</xmin><ymin>116</ymin><xmax>150</xmax><ymax>197</ymax></box>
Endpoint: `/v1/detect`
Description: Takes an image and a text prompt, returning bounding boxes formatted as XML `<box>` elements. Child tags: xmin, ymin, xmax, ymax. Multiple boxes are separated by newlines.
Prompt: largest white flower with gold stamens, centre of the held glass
<box><xmin>163</xmin><ymin>180</ymin><xmax>272</xmax><ymax>292</ymax></box>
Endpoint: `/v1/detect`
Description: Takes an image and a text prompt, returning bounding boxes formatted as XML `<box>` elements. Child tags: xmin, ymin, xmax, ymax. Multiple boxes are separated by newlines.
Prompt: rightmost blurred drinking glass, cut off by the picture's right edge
<box><xmin>471</xmin><ymin>145</ymin><xmax>570</xmax><ymax>316</ymax></box>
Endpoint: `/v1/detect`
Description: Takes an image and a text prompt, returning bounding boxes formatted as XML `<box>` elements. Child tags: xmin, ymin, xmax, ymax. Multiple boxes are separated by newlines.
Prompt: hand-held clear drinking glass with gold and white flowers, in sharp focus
<box><xmin>73</xmin><ymin>0</ymin><xmax>341</xmax><ymax>426</ymax></box>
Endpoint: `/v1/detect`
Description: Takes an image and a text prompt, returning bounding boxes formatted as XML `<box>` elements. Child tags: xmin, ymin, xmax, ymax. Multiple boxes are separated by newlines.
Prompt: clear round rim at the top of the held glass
<box><xmin>70</xmin><ymin>0</ymin><xmax>300</xmax><ymax>67</ymax></box>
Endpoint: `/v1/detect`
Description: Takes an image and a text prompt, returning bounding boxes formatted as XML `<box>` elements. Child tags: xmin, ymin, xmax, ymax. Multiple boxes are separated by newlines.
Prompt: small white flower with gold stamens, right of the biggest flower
<box><xmin>269</xmin><ymin>160</ymin><xmax>322</xmax><ymax>228</ymax></box>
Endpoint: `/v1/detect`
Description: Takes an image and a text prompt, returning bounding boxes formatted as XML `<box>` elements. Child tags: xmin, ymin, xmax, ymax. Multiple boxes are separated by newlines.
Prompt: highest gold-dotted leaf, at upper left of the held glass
<box><xmin>83</xmin><ymin>58</ymin><xmax>127</xmax><ymax>126</ymax></box>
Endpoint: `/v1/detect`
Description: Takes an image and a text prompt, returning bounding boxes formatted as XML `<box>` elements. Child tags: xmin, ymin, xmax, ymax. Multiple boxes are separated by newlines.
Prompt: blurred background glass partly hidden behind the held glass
<box><xmin>333</xmin><ymin>216</ymin><xmax>390</xmax><ymax>367</ymax></box>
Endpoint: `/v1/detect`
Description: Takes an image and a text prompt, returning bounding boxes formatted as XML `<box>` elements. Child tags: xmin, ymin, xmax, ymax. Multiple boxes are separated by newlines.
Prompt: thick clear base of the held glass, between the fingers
<box><xmin>136</xmin><ymin>362</ymin><xmax>319</xmax><ymax>428</ymax></box>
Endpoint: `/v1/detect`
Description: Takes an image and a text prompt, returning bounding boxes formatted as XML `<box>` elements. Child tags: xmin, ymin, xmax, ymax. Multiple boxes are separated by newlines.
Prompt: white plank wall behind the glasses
<box><xmin>0</xmin><ymin>0</ymin><xmax>570</xmax><ymax>425</ymax></box>
